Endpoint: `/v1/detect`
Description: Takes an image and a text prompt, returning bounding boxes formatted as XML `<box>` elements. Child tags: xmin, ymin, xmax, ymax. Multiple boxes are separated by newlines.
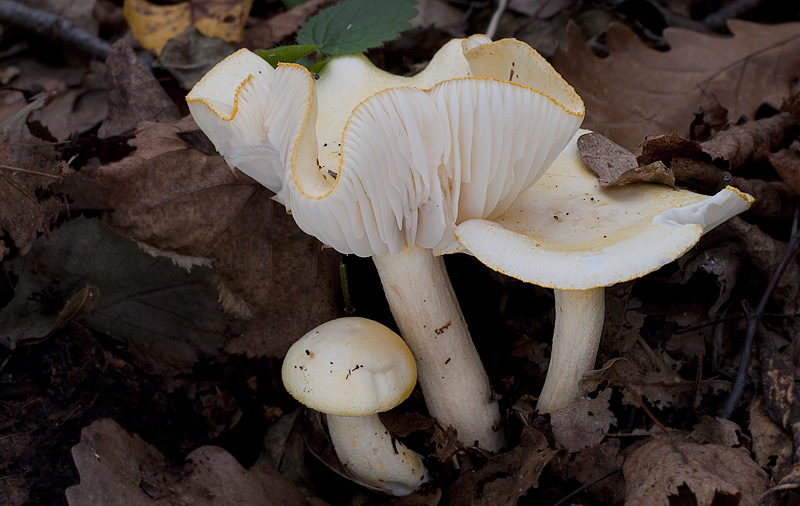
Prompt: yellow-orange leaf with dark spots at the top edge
<box><xmin>124</xmin><ymin>0</ymin><xmax>253</xmax><ymax>54</ymax></box>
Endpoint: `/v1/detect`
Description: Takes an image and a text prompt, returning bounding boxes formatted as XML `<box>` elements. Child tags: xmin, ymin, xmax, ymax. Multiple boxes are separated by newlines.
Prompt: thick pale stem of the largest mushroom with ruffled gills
<box><xmin>372</xmin><ymin>246</ymin><xmax>504</xmax><ymax>452</ymax></box>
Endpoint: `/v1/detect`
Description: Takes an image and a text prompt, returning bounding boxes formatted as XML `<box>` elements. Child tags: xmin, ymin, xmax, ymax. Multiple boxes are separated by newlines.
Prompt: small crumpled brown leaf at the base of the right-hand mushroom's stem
<box><xmin>550</xmin><ymin>388</ymin><xmax>617</xmax><ymax>452</ymax></box>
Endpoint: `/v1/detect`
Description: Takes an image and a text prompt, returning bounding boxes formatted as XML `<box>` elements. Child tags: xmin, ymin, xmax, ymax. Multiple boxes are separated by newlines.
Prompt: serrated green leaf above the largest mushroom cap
<box><xmin>297</xmin><ymin>0</ymin><xmax>417</xmax><ymax>56</ymax></box>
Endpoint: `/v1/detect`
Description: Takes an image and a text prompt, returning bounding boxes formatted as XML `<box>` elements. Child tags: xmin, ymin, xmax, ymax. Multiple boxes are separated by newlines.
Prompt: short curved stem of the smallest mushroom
<box><xmin>328</xmin><ymin>415</ymin><xmax>430</xmax><ymax>496</ymax></box>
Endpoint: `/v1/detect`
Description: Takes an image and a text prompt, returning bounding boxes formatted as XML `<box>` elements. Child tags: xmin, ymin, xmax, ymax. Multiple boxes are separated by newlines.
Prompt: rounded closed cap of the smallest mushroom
<box><xmin>281</xmin><ymin>318</ymin><xmax>417</xmax><ymax>416</ymax></box>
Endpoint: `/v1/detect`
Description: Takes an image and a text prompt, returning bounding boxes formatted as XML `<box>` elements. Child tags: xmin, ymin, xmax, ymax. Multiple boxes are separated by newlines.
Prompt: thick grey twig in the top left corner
<box><xmin>0</xmin><ymin>0</ymin><xmax>111</xmax><ymax>60</ymax></box>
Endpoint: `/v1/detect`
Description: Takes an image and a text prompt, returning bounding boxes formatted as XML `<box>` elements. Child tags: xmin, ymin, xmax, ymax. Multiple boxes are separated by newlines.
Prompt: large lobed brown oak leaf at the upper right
<box><xmin>553</xmin><ymin>19</ymin><xmax>800</xmax><ymax>148</ymax></box>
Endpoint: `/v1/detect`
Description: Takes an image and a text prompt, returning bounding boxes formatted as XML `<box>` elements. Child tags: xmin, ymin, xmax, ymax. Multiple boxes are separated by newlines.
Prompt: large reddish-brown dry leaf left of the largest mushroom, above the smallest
<box><xmin>97</xmin><ymin>116</ymin><xmax>339</xmax><ymax>358</ymax></box>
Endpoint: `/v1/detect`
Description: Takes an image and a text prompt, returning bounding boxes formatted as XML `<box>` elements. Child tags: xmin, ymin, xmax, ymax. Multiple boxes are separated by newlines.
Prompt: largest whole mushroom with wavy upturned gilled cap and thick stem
<box><xmin>187</xmin><ymin>36</ymin><xmax>584</xmax><ymax>451</ymax></box>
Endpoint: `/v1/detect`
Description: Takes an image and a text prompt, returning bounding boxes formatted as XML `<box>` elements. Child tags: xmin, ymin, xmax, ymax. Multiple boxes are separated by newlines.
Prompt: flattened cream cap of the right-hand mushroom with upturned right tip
<box><xmin>454</xmin><ymin>130</ymin><xmax>753</xmax><ymax>290</ymax></box>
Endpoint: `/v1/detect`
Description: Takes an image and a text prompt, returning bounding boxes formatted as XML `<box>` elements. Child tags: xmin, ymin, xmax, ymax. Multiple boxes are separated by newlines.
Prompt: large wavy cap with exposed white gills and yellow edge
<box><xmin>187</xmin><ymin>36</ymin><xmax>584</xmax><ymax>256</ymax></box>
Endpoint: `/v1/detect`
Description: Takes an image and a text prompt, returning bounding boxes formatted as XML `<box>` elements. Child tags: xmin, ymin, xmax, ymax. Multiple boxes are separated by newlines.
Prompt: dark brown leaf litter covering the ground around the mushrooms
<box><xmin>0</xmin><ymin>0</ymin><xmax>800</xmax><ymax>505</ymax></box>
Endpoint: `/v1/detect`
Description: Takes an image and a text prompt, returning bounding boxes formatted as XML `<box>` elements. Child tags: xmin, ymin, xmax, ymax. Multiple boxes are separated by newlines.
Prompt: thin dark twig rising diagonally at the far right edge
<box><xmin>719</xmin><ymin>204</ymin><xmax>800</xmax><ymax>419</ymax></box>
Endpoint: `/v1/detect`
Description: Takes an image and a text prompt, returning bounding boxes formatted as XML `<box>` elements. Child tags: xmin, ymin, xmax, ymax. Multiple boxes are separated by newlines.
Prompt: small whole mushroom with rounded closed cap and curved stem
<box><xmin>282</xmin><ymin>318</ymin><xmax>429</xmax><ymax>496</ymax></box>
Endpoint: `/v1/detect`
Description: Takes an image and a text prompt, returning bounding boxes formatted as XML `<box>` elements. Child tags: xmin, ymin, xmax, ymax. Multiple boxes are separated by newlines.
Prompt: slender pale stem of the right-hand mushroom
<box><xmin>536</xmin><ymin>288</ymin><xmax>605</xmax><ymax>413</ymax></box>
